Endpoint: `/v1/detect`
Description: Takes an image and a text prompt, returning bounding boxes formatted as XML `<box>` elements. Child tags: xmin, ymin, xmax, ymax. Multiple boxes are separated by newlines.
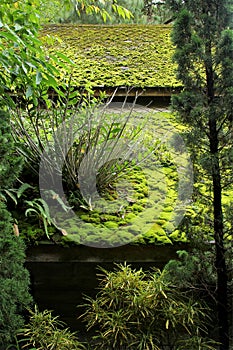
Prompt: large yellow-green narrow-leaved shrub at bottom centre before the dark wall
<box><xmin>81</xmin><ymin>265</ymin><xmax>217</xmax><ymax>350</ymax></box>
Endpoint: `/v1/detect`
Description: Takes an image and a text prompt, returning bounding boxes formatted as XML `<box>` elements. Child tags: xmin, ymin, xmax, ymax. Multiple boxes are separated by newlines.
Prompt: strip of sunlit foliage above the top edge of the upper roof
<box><xmin>37</xmin><ymin>0</ymin><xmax>171</xmax><ymax>24</ymax></box>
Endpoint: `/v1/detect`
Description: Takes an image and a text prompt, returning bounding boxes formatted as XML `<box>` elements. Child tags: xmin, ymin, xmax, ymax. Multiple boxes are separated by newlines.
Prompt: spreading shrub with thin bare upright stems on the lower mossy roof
<box><xmin>12</xmin><ymin>96</ymin><xmax>153</xmax><ymax>212</ymax></box>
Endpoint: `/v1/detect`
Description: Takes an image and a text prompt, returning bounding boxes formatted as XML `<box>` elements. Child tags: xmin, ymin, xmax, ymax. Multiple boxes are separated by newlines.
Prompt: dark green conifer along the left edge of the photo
<box><xmin>0</xmin><ymin>111</ymin><xmax>31</xmax><ymax>349</ymax></box>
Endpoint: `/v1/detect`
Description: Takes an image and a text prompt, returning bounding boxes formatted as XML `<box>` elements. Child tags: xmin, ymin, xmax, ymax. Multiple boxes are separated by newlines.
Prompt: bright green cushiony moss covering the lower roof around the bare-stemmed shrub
<box><xmin>11</xmin><ymin>110</ymin><xmax>233</xmax><ymax>246</ymax></box>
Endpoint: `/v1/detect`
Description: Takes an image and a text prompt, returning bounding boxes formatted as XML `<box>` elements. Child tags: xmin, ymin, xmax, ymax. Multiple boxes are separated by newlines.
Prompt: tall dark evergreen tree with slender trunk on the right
<box><xmin>167</xmin><ymin>0</ymin><xmax>233</xmax><ymax>350</ymax></box>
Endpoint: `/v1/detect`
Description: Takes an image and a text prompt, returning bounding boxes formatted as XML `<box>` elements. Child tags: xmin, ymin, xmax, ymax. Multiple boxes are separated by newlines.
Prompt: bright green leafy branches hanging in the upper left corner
<box><xmin>0</xmin><ymin>0</ymin><xmax>73</xmax><ymax>109</ymax></box>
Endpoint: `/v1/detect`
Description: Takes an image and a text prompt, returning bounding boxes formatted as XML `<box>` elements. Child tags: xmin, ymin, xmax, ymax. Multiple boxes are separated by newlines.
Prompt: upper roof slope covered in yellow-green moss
<box><xmin>42</xmin><ymin>24</ymin><xmax>181</xmax><ymax>90</ymax></box>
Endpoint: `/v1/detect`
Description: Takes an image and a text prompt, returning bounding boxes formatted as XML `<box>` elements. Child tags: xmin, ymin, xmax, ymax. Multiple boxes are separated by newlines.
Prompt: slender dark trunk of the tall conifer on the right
<box><xmin>206</xmin><ymin>52</ymin><xmax>229</xmax><ymax>350</ymax></box>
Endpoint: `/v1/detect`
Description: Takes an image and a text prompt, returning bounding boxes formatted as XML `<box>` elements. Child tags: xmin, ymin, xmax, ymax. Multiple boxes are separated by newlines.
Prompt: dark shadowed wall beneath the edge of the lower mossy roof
<box><xmin>26</xmin><ymin>245</ymin><xmax>187</xmax><ymax>330</ymax></box>
